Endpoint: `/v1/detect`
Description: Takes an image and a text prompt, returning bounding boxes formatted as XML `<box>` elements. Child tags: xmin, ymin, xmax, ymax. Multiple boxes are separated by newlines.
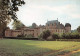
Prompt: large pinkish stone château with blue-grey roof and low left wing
<box><xmin>5</xmin><ymin>20</ymin><xmax>71</xmax><ymax>38</ymax></box>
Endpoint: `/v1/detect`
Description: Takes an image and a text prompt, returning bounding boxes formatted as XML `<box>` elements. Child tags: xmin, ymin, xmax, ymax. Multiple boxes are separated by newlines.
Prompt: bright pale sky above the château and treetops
<box><xmin>8</xmin><ymin>0</ymin><xmax>80</xmax><ymax>30</ymax></box>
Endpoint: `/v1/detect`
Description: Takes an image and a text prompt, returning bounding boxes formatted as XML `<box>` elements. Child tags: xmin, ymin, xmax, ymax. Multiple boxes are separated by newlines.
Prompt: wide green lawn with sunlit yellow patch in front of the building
<box><xmin>0</xmin><ymin>39</ymin><xmax>80</xmax><ymax>56</ymax></box>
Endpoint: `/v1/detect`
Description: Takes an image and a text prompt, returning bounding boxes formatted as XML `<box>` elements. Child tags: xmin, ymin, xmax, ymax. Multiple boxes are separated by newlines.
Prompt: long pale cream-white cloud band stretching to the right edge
<box><xmin>27</xmin><ymin>4</ymin><xmax>80</xmax><ymax>18</ymax></box>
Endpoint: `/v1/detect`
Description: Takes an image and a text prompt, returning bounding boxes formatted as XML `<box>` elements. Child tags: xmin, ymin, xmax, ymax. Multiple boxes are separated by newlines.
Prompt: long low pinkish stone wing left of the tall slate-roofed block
<box><xmin>5</xmin><ymin>29</ymin><xmax>39</xmax><ymax>37</ymax></box>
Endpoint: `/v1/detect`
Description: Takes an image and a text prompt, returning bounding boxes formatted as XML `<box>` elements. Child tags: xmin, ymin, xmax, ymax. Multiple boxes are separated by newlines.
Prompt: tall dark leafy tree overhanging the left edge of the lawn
<box><xmin>0</xmin><ymin>0</ymin><xmax>25</xmax><ymax>35</ymax></box>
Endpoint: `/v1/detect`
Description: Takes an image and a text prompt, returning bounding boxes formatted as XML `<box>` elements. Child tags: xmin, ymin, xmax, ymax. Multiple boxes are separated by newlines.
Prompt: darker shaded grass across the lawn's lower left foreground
<box><xmin>0</xmin><ymin>42</ymin><xmax>53</xmax><ymax>56</ymax></box>
